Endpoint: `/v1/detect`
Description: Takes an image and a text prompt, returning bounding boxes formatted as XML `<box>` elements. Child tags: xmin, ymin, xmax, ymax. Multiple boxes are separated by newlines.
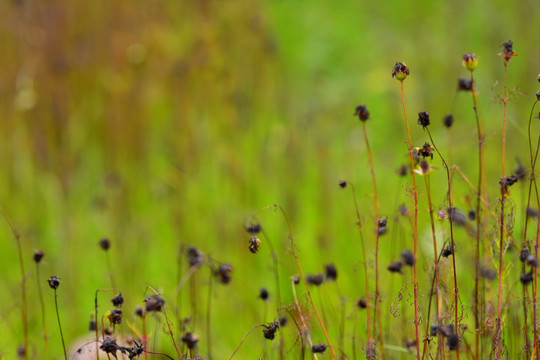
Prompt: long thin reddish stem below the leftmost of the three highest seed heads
<box><xmin>400</xmin><ymin>80</ymin><xmax>422</xmax><ymax>360</ymax></box>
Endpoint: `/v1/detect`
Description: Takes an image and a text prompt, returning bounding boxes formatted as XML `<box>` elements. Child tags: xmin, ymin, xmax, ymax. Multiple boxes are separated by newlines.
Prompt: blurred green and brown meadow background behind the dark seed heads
<box><xmin>0</xmin><ymin>0</ymin><xmax>540</xmax><ymax>358</ymax></box>
